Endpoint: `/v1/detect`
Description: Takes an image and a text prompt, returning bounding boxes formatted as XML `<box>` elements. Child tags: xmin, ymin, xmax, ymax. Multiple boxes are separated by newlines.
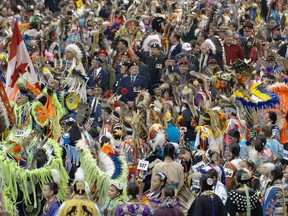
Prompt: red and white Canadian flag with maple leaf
<box><xmin>6</xmin><ymin>22</ymin><xmax>38</xmax><ymax>97</ymax></box>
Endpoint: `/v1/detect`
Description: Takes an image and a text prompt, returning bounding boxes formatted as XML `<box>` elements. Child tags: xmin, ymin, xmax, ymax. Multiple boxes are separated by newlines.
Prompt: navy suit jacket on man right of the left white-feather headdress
<box><xmin>87</xmin><ymin>68</ymin><xmax>108</xmax><ymax>91</ymax></box>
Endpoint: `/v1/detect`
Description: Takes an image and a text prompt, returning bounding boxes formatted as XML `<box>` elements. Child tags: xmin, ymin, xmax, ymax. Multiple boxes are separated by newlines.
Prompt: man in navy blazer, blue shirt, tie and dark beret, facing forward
<box><xmin>120</xmin><ymin>62</ymin><xmax>147</xmax><ymax>107</ymax></box>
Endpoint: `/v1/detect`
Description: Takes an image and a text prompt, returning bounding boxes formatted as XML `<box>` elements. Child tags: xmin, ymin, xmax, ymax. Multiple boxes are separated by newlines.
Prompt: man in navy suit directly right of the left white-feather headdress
<box><xmin>87</xmin><ymin>57</ymin><xmax>108</xmax><ymax>91</ymax></box>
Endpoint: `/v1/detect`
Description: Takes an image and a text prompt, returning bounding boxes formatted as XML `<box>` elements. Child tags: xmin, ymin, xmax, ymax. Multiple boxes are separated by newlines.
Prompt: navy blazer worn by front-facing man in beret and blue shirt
<box><xmin>120</xmin><ymin>74</ymin><xmax>147</xmax><ymax>102</ymax></box>
